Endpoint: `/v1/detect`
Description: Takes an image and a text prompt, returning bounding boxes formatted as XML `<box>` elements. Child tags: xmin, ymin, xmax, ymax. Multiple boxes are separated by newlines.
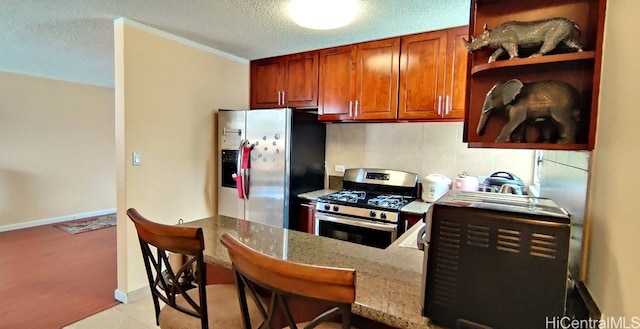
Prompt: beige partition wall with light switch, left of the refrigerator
<box><xmin>114</xmin><ymin>19</ymin><xmax>249</xmax><ymax>294</ymax></box>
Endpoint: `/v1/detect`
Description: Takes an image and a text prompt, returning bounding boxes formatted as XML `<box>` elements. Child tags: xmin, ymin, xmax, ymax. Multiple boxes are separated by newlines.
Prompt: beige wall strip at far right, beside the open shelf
<box><xmin>587</xmin><ymin>0</ymin><xmax>640</xmax><ymax>323</ymax></box>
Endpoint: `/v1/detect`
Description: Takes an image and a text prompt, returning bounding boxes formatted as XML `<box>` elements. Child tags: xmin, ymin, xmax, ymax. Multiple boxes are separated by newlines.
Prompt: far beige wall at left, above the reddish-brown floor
<box><xmin>0</xmin><ymin>72</ymin><xmax>116</xmax><ymax>227</ymax></box>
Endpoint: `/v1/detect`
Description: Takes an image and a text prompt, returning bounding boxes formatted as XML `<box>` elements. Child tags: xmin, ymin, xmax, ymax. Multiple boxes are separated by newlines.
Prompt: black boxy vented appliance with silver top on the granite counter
<box><xmin>421</xmin><ymin>191</ymin><xmax>571</xmax><ymax>329</ymax></box>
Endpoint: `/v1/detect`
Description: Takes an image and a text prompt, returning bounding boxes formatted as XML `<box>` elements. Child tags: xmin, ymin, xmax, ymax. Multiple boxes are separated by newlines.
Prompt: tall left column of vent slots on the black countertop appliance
<box><xmin>433</xmin><ymin>220</ymin><xmax>461</xmax><ymax>307</ymax></box>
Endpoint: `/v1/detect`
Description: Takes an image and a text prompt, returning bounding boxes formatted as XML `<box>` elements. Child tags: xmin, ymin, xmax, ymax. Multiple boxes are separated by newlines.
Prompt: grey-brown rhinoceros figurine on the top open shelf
<box><xmin>463</xmin><ymin>17</ymin><xmax>582</xmax><ymax>63</ymax></box>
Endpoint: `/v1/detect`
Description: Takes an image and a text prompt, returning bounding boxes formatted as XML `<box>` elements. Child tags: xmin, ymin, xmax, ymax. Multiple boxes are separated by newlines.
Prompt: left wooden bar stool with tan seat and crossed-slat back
<box><xmin>127</xmin><ymin>208</ymin><xmax>259</xmax><ymax>329</ymax></box>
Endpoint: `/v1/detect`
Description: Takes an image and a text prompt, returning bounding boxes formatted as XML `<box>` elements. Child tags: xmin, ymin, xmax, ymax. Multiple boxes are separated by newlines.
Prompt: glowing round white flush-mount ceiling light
<box><xmin>287</xmin><ymin>0</ymin><xmax>360</xmax><ymax>30</ymax></box>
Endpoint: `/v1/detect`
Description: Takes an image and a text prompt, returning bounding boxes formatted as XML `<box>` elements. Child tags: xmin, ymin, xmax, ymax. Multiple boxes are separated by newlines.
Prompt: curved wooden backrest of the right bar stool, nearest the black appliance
<box><xmin>220</xmin><ymin>233</ymin><xmax>356</xmax><ymax>329</ymax></box>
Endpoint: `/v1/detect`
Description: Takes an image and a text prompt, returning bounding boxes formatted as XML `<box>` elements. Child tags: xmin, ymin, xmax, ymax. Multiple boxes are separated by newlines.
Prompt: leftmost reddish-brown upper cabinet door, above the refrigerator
<box><xmin>251</xmin><ymin>58</ymin><xmax>284</xmax><ymax>109</ymax></box>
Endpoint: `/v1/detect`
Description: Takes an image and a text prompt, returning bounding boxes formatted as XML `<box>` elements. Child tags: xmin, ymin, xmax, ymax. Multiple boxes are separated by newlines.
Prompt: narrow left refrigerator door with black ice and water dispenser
<box><xmin>216</xmin><ymin>110</ymin><xmax>246</xmax><ymax>218</ymax></box>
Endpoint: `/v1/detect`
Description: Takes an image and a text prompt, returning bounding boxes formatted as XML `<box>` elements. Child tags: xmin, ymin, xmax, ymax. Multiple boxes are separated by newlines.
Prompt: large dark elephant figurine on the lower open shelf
<box><xmin>476</xmin><ymin>79</ymin><xmax>580</xmax><ymax>144</ymax></box>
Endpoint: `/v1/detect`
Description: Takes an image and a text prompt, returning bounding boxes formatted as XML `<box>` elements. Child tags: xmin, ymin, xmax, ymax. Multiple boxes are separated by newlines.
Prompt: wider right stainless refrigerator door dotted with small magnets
<box><xmin>245</xmin><ymin>109</ymin><xmax>291</xmax><ymax>227</ymax></box>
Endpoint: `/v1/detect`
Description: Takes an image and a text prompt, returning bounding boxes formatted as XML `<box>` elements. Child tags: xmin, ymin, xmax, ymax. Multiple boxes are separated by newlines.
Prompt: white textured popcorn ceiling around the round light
<box><xmin>0</xmin><ymin>0</ymin><xmax>470</xmax><ymax>87</ymax></box>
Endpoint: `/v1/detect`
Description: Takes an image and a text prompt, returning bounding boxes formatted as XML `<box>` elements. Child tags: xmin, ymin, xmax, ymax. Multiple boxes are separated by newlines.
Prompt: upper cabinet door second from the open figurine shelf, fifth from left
<box><xmin>398</xmin><ymin>31</ymin><xmax>447</xmax><ymax>119</ymax></box>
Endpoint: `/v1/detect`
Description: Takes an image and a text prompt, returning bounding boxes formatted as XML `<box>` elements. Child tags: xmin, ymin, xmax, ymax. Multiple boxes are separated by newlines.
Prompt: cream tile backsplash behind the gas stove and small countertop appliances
<box><xmin>326</xmin><ymin>122</ymin><xmax>535</xmax><ymax>184</ymax></box>
